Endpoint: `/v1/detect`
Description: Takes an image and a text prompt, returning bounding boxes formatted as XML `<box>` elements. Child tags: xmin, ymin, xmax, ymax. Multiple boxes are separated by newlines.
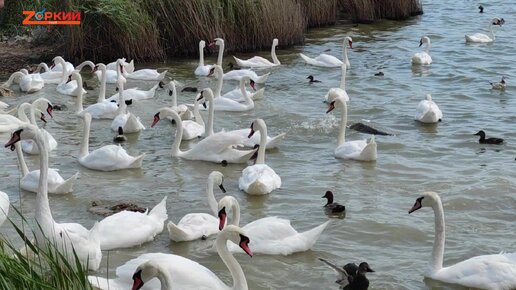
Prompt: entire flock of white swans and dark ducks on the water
<box><xmin>0</xmin><ymin>11</ymin><xmax>516</xmax><ymax>290</ymax></box>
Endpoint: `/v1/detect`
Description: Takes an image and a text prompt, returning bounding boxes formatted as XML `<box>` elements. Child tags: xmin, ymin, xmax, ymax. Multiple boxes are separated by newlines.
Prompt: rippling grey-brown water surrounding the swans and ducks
<box><xmin>0</xmin><ymin>1</ymin><xmax>516</xmax><ymax>289</ymax></box>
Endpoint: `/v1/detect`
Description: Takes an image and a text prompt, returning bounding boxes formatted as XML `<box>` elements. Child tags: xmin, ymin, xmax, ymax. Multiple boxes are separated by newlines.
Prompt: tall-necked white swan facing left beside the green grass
<box><xmin>5</xmin><ymin>124</ymin><xmax>102</xmax><ymax>271</ymax></box>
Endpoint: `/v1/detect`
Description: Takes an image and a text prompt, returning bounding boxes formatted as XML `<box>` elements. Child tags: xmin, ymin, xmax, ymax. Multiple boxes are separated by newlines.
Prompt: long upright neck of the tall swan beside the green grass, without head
<box><xmin>34</xmin><ymin>129</ymin><xmax>54</xmax><ymax>229</ymax></box>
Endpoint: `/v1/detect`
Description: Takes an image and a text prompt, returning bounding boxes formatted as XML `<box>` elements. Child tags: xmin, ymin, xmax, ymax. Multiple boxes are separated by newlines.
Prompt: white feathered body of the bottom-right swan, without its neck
<box><xmin>430</xmin><ymin>253</ymin><xmax>516</xmax><ymax>290</ymax></box>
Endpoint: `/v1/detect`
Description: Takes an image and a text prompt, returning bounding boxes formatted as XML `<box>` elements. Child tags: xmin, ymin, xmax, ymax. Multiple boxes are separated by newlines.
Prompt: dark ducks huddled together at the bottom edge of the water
<box><xmin>319</xmin><ymin>258</ymin><xmax>374</xmax><ymax>290</ymax></box>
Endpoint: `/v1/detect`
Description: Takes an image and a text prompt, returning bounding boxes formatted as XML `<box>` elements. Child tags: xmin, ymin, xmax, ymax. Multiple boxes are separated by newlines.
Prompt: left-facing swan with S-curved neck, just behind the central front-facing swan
<box><xmin>151</xmin><ymin>107</ymin><xmax>255</xmax><ymax>163</ymax></box>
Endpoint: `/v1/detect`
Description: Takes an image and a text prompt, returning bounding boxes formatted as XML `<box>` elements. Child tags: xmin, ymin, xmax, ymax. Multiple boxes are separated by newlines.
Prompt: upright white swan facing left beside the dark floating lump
<box><xmin>326</xmin><ymin>94</ymin><xmax>377</xmax><ymax>161</ymax></box>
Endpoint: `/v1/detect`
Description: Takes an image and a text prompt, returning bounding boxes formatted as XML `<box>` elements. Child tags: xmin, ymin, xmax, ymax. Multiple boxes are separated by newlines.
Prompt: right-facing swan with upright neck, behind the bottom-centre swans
<box><xmin>167</xmin><ymin>171</ymin><xmax>226</xmax><ymax>242</ymax></box>
